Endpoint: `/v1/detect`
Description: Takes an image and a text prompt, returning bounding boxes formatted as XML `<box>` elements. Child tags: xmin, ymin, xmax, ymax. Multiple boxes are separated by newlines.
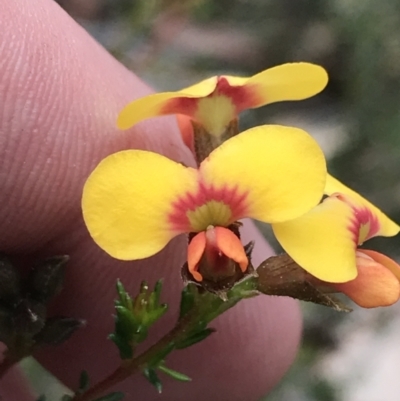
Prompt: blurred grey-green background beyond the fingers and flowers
<box><xmin>47</xmin><ymin>0</ymin><xmax>400</xmax><ymax>401</ymax></box>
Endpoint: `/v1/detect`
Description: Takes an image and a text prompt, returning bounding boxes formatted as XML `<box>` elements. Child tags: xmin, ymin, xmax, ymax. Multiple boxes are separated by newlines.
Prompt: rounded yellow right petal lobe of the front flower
<box><xmin>200</xmin><ymin>125</ymin><xmax>326</xmax><ymax>223</ymax></box>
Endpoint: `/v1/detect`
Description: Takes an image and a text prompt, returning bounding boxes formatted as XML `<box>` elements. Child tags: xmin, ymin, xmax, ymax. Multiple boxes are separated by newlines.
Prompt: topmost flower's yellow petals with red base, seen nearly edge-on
<box><xmin>117</xmin><ymin>63</ymin><xmax>328</xmax><ymax>136</ymax></box>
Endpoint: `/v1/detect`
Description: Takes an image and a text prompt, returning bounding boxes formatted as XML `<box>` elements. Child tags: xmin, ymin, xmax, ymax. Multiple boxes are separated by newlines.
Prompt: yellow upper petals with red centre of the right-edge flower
<box><xmin>273</xmin><ymin>175</ymin><xmax>400</xmax><ymax>288</ymax></box>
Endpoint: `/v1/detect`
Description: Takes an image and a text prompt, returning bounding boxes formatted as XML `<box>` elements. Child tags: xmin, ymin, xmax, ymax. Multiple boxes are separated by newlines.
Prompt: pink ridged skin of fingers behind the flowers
<box><xmin>0</xmin><ymin>0</ymin><xmax>301</xmax><ymax>401</ymax></box>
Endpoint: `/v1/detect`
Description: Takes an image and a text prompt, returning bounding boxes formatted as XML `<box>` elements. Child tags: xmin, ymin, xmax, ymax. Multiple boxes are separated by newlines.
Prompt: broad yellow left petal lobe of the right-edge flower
<box><xmin>272</xmin><ymin>197</ymin><xmax>357</xmax><ymax>283</ymax></box>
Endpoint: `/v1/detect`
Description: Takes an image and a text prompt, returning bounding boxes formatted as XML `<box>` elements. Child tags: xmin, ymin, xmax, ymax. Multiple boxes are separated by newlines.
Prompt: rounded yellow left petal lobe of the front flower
<box><xmin>82</xmin><ymin>150</ymin><xmax>198</xmax><ymax>260</ymax></box>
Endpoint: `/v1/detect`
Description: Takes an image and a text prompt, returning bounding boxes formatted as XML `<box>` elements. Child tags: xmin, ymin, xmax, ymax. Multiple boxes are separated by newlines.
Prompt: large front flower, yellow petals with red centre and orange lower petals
<box><xmin>82</xmin><ymin>125</ymin><xmax>326</xmax><ymax>281</ymax></box>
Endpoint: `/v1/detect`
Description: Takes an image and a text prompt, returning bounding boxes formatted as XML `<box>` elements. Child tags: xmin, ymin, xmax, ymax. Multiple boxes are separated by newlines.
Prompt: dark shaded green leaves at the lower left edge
<box><xmin>0</xmin><ymin>256</ymin><xmax>84</xmax><ymax>361</ymax></box>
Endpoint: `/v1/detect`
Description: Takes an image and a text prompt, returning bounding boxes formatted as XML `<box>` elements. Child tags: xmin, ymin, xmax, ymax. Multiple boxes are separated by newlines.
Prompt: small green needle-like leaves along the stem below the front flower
<box><xmin>110</xmin><ymin>279</ymin><xmax>255</xmax><ymax>393</ymax></box>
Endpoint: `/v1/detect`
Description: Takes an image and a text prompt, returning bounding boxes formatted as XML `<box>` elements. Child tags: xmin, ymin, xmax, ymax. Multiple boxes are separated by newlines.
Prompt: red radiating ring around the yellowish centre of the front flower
<box><xmin>168</xmin><ymin>182</ymin><xmax>247</xmax><ymax>232</ymax></box>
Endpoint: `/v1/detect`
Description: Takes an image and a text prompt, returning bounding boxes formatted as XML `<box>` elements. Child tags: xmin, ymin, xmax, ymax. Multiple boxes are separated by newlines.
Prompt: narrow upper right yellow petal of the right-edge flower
<box><xmin>325</xmin><ymin>174</ymin><xmax>400</xmax><ymax>237</ymax></box>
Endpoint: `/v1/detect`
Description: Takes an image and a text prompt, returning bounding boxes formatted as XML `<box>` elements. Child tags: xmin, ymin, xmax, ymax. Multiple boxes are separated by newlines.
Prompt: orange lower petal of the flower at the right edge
<box><xmin>331</xmin><ymin>250</ymin><xmax>400</xmax><ymax>308</ymax></box>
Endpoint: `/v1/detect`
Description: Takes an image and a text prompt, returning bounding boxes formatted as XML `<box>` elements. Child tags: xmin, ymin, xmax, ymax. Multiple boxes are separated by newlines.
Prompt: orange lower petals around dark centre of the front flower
<box><xmin>187</xmin><ymin>226</ymin><xmax>249</xmax><ymax>282</ymax></box>
